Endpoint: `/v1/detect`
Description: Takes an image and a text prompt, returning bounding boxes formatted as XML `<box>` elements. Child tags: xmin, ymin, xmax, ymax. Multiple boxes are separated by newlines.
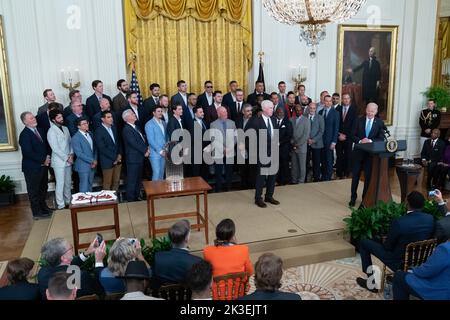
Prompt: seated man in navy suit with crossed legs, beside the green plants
<box><xmin>356</xmin><ymin>191</ymin><xmax>434</xmax><ymax>292</ymax></box>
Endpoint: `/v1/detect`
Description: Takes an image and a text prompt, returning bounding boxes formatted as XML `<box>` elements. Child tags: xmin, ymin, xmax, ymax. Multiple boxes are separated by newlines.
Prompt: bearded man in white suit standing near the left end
<box><xmin>47</xmin><ymin>110</ymin><xmax>73</xmax><ymax>209</ymax></box>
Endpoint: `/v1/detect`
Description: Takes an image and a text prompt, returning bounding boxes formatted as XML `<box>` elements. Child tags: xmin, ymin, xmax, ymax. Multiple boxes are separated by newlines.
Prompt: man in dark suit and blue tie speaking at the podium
<box><xmin>349</xmin><ymin>103</ymin><xmax>384</xmax><ymax>207</ymax></box>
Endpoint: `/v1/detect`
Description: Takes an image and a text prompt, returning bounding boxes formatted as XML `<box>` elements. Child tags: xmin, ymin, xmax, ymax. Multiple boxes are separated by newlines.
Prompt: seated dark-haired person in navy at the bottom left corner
<box><xmin>0</xmin><ymin>258</ymin><xmax>40</xmax><ymax>300</ymax></box>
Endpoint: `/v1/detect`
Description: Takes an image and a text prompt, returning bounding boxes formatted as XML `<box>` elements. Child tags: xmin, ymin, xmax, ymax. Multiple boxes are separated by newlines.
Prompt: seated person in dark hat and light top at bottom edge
<box><xmin>121</xmin><ymin>261</ymin><xmax>162</xmax><ymax>300</ymax></box>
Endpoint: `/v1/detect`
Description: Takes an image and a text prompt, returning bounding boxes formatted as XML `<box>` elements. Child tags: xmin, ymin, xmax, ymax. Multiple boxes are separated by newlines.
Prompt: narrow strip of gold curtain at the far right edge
<box><xmin>433</xmin><ymin>17</ymin><xmax>450</xmax><ymax>85</ymax></box>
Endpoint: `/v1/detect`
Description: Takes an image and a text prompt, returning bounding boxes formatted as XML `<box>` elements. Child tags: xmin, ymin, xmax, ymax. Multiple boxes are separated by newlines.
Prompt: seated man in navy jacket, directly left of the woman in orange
<box><xmin>151</xmin><ymin>220</ymin><xmax>201</xmax><ymax>289</ymax></box>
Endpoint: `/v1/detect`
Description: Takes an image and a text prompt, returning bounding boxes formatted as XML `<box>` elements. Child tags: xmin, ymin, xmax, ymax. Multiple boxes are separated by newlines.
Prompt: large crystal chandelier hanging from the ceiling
<box><xmin>263</xmin><ymin>0</ymin><xmax>366</xmax><ymax>58</ymax></box>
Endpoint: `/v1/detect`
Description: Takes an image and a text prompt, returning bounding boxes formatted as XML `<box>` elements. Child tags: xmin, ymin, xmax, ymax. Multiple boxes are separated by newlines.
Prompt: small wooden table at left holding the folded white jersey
<box><xmin>69</xmin><ymin>201</ymin><xmax>120</xmax><ymax>253</ymax></box>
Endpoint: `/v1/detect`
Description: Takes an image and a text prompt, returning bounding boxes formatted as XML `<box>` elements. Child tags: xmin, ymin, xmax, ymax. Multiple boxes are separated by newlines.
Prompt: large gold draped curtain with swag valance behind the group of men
<box><xmin>124</xmin><ymin>0</ymin><xmax>253</xmax><ymax>96</ymax></box>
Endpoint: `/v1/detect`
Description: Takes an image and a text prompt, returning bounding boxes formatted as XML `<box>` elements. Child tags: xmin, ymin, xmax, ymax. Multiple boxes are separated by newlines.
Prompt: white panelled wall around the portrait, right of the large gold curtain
<box><xmin>249</xmin><ymin>0</ymin><xmax>437</xmax><ymax>160</ymax></box>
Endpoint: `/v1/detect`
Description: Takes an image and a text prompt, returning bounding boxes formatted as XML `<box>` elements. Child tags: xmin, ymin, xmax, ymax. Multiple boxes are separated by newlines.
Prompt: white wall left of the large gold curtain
<box><xmin>0</xmin><ymin>0</ymin><xmax>126</xmax><ymax>193</ymax></box>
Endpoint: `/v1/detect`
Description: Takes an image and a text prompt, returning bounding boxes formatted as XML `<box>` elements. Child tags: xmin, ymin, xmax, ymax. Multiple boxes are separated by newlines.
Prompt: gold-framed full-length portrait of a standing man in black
<box><xmin>336</xmin><ymin>25</ymin><xmax>398</xmax><ymax>126</ymax></box>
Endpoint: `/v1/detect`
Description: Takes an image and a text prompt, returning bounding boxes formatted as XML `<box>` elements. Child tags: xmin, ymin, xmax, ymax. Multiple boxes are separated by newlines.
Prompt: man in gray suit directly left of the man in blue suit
<box><xmin>305</xmin><ymin>102</ymin><xmax>325</xmax><ymax>182</ymax></box>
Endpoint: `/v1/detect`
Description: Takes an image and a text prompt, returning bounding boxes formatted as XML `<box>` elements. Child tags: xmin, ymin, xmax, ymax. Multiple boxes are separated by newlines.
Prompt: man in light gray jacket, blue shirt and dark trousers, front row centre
<box><xmin>210</xmin><ymin>107</ymin><xmax>236</xmax><ymax>192</ymax></box>
